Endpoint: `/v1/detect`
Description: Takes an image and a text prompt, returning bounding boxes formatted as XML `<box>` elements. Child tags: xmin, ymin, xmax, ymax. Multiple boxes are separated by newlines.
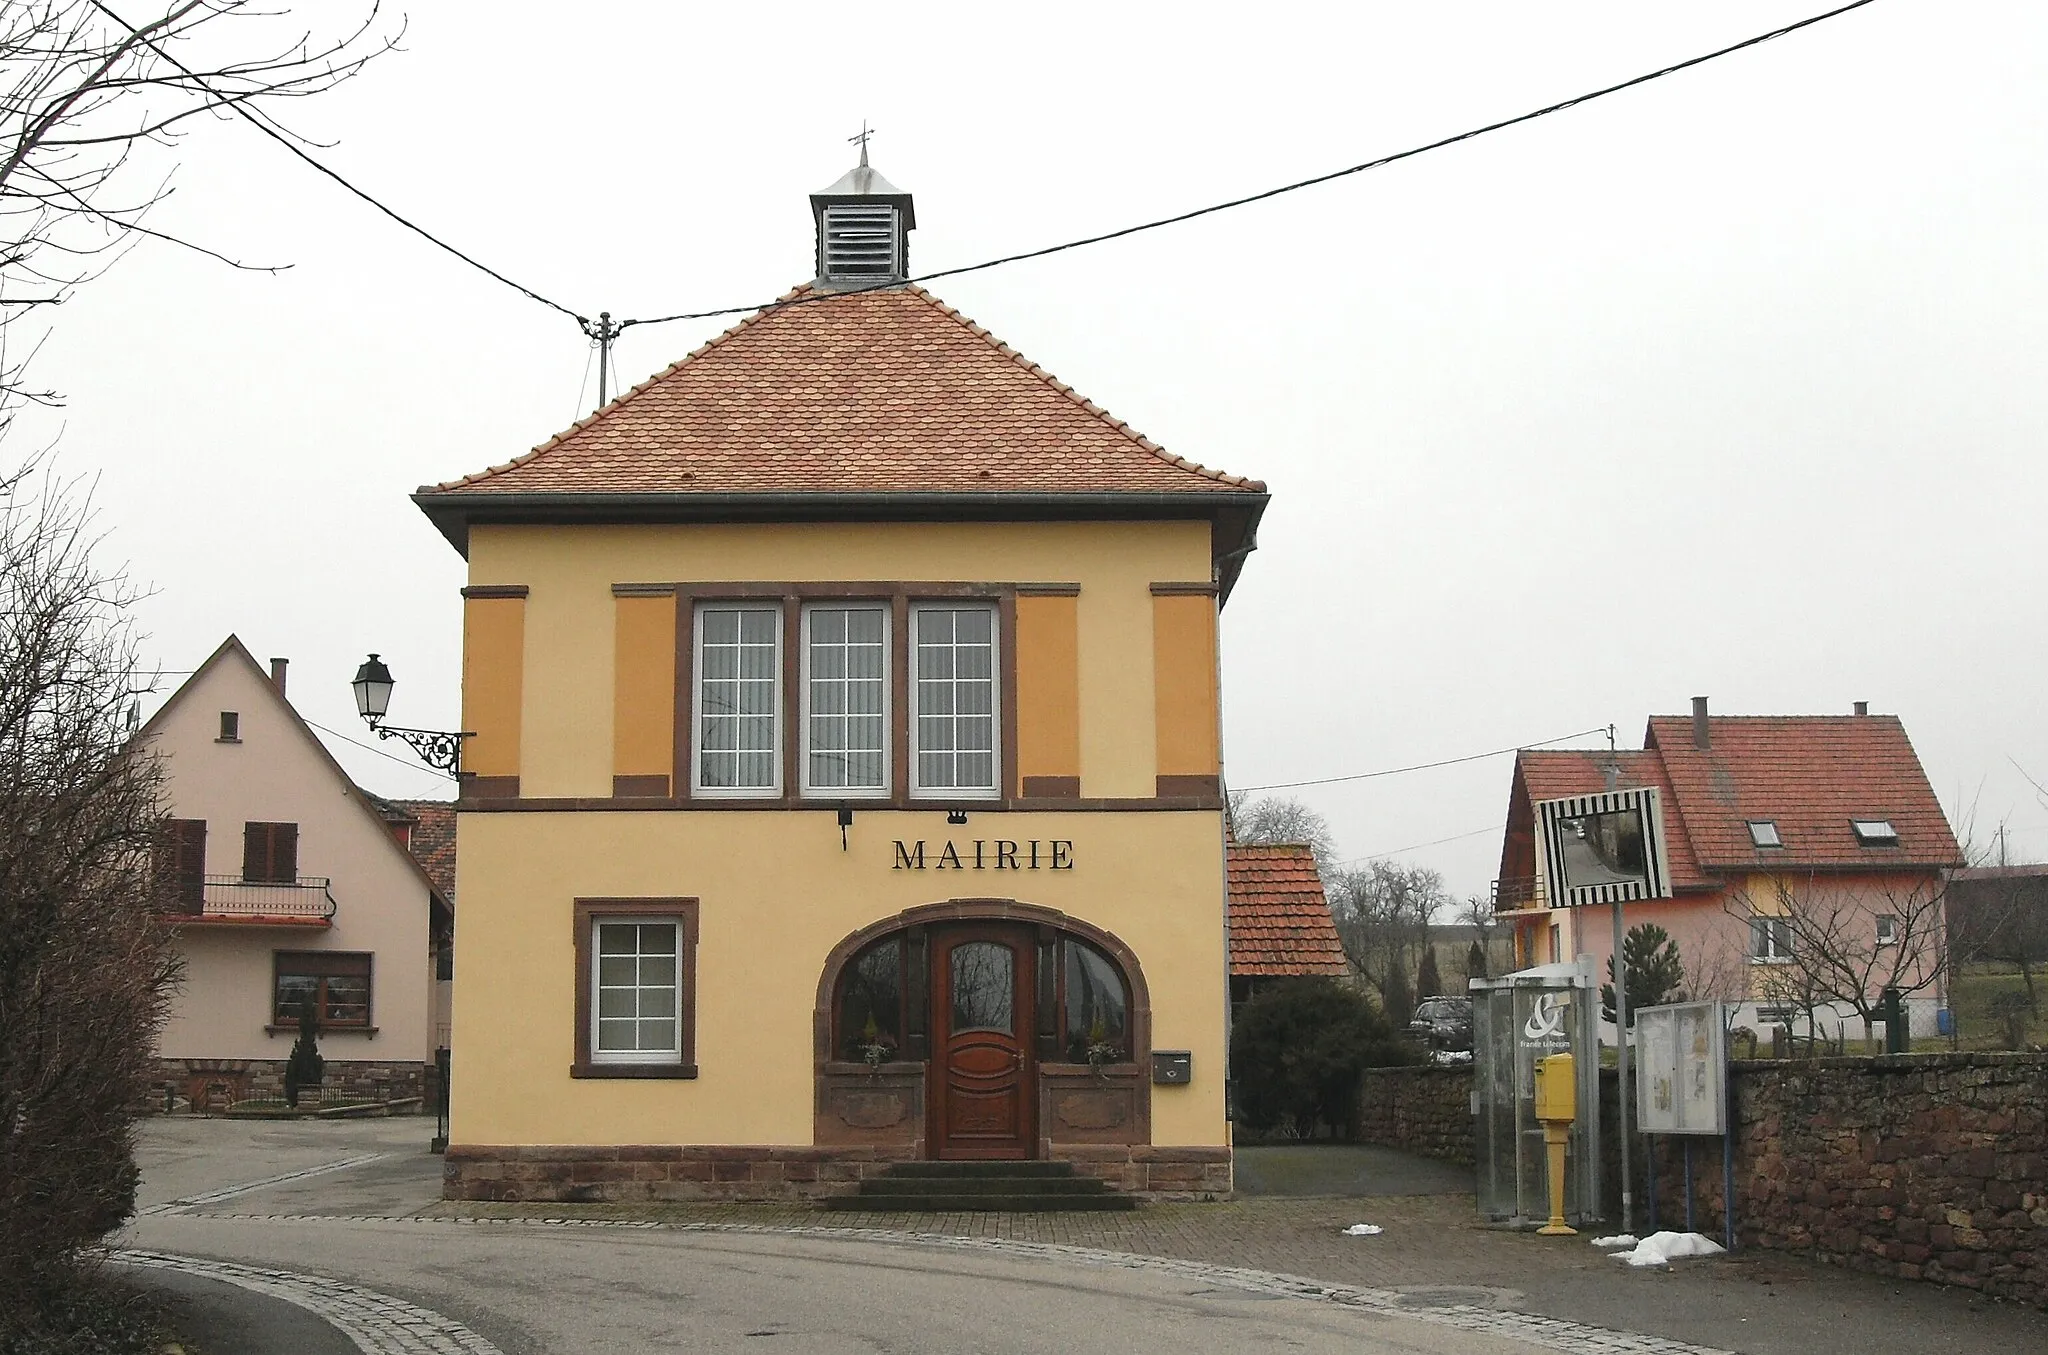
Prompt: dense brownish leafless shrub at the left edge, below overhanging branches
<box><xmin>0</xmin><ymin>471</ymin><xmax>174</xmax><ymax>1309</ymax></box>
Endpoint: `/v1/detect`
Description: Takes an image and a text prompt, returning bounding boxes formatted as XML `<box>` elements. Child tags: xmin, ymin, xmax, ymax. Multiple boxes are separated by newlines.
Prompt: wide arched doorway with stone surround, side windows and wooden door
<box><xmin>815</xmin><ymin>899</ymin><xmax>1151</xmax><ymax>1161</ymax></box>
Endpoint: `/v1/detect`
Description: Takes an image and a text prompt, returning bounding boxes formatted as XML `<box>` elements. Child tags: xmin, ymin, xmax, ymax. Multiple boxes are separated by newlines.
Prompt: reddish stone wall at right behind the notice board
<box><xmin>1657</xmin><ymin>1054</ymin><xmax>2048</xmax><ymax>1308</ymax></box>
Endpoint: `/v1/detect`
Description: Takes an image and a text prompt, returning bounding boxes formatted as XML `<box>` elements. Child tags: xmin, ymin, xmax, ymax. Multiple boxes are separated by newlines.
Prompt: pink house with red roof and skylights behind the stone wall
<box><xmin>1493</xmin><ymin>698</ymin><xmax>1962</xmax><ymax>1036</ymax></box>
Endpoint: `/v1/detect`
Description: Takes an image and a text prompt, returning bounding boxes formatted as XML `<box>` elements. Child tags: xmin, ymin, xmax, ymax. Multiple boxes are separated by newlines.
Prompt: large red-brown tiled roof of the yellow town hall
<box><xmin>420</xmin><ymin>287</ymin><xmax>1266</xmax><ymax>501</ymax></box>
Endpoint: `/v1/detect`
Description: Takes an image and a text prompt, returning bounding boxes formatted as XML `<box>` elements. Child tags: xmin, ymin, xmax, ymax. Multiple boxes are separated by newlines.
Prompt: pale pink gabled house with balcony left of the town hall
<box><xmin>135</xmin><ymin>637</ymin><xmax>453</xmax><ymax>1109</ymax></box>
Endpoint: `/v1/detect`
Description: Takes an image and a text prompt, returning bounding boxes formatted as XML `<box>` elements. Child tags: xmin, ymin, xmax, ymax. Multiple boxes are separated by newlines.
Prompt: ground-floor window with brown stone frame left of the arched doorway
<box><xmin>571</xmin><ymin>899</ymin><xmax>696</xmax><ymax>1077</ymax></box>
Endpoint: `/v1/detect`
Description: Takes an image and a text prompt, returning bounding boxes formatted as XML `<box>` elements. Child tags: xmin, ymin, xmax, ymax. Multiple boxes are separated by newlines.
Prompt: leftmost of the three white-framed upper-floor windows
<box><xmin>694</xmin><ymin>604</ymin><xmax>782</xmax><ymax>796</ymax></box>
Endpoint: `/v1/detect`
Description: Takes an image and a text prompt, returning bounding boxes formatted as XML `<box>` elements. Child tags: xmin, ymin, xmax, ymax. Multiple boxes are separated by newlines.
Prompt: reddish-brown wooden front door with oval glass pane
<box><xmin>928</xmin><ymin>923</ymin><xmax>1038</xmax><ymax>1159</ymax></box>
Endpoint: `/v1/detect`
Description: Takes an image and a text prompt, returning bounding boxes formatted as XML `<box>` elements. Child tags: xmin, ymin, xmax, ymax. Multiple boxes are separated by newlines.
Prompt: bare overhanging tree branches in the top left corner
<box><xmin>0</xmin><ymin>0</ymin><xmax>397</xmax><ymax>409</ymax></box>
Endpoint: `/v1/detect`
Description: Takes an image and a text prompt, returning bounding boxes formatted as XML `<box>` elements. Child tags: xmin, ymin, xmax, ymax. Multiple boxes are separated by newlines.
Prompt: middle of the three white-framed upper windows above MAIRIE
<box><xmin>803</xmin><ymin>602</ymin><xmax>889</xmax><ymax>796</ymax></box>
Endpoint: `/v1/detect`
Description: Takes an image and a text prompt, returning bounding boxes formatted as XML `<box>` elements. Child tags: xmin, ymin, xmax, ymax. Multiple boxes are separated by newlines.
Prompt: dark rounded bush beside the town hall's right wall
<box><xmin>1231</xmin><ymin>978</ymin><xmax>1417</xmax><ymax>1138</ymax></box>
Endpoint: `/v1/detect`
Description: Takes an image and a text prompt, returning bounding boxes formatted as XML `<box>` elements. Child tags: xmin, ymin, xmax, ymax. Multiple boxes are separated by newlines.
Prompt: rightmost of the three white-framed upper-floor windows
<box><xmin>909</xmin><ymin>604</ymin><xmax>999</xmax><ymax>798</ymax></box>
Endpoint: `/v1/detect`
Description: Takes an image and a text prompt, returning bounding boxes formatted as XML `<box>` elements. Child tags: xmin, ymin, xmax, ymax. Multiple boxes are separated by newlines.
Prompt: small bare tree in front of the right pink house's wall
<box><xmin>1726</xmin><ymin>876</ymin><xmax>1950</xmax><ymax>1042</ymax></box>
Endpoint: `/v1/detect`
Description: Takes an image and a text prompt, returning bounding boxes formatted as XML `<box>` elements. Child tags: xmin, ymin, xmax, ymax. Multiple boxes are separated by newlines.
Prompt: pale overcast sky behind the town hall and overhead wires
<box><xmin>36</xmin><ymin>0</ymin><xmax>2048</xmax><ymax>908</ymax></box>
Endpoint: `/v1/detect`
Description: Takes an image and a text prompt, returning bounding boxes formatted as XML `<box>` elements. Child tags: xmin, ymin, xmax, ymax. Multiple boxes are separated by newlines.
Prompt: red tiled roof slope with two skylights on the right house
<box><xmin>1642</xmin><ymin>714</ymin><xmax>1962</xmax><ymax>868</ymax></box>
